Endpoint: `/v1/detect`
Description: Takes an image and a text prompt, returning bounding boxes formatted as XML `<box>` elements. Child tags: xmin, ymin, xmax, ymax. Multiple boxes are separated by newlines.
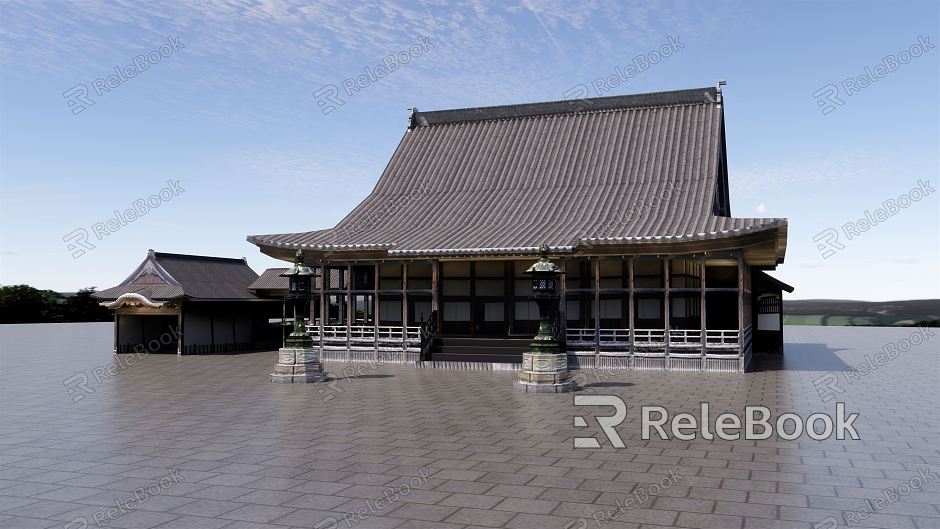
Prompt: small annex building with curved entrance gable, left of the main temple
<box><xmin>95</xmin><ymin>250</ymin><xmax>285</xmax><ymax>354</ymax></box>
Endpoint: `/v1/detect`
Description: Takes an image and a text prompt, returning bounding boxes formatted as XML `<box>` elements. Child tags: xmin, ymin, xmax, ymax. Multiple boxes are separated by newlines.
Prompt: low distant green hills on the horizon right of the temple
<box><xmin>783</xmin><ymin>299</ymin><xmax>940</xmax><ymax>327</ymax></box>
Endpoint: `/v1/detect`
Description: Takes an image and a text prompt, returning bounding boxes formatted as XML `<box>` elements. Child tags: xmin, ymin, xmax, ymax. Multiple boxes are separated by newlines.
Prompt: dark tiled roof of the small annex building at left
<box><xmin>95</xmin><ymin>250</ymin><xmax>258</xmax><ymax>300</ymax></box>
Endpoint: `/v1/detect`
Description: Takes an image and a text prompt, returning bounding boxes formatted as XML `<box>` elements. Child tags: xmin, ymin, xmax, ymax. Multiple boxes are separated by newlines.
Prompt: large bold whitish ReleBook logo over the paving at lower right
<box><xmin>574</xmin><ymin>395</ymin><xmax>859</xmax><ymax>448</ymax></box>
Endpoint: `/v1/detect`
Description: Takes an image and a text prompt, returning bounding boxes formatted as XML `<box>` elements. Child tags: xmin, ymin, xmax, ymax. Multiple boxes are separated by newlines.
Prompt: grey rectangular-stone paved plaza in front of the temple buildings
<box><xmin>0</xmin><ymin>323</ymin><xmax>940</xmax><ymax>529</ymax></box>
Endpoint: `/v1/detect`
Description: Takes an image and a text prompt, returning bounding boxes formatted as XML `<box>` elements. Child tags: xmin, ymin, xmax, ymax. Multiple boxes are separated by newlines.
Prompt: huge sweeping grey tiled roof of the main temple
<box><xmin>248</xmin><ymin>88</ymin><xmax>786</xmax><ymax>256</ymax></box>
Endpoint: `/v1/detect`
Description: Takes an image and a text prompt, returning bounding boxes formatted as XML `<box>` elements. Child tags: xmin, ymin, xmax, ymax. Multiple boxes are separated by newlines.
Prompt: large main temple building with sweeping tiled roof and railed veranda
<box><xmin>248</xmin><ymin>87</ymin><xmax>792</xmax><ymax>372</ymax></box>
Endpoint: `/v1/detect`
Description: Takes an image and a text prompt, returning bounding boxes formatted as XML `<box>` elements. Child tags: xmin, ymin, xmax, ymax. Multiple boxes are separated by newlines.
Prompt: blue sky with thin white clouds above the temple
<box><xmin>0</xmin><ymin>0</ymin><xmax>940</xmax><ymax>300</ymax></box>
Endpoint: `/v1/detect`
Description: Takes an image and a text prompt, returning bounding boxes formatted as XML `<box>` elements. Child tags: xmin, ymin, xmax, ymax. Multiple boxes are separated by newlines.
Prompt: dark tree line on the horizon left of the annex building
<box><xmin>0</xmin><ymin>285</ymin><xmax>113</xmax><ymax>323</ymax></box>
